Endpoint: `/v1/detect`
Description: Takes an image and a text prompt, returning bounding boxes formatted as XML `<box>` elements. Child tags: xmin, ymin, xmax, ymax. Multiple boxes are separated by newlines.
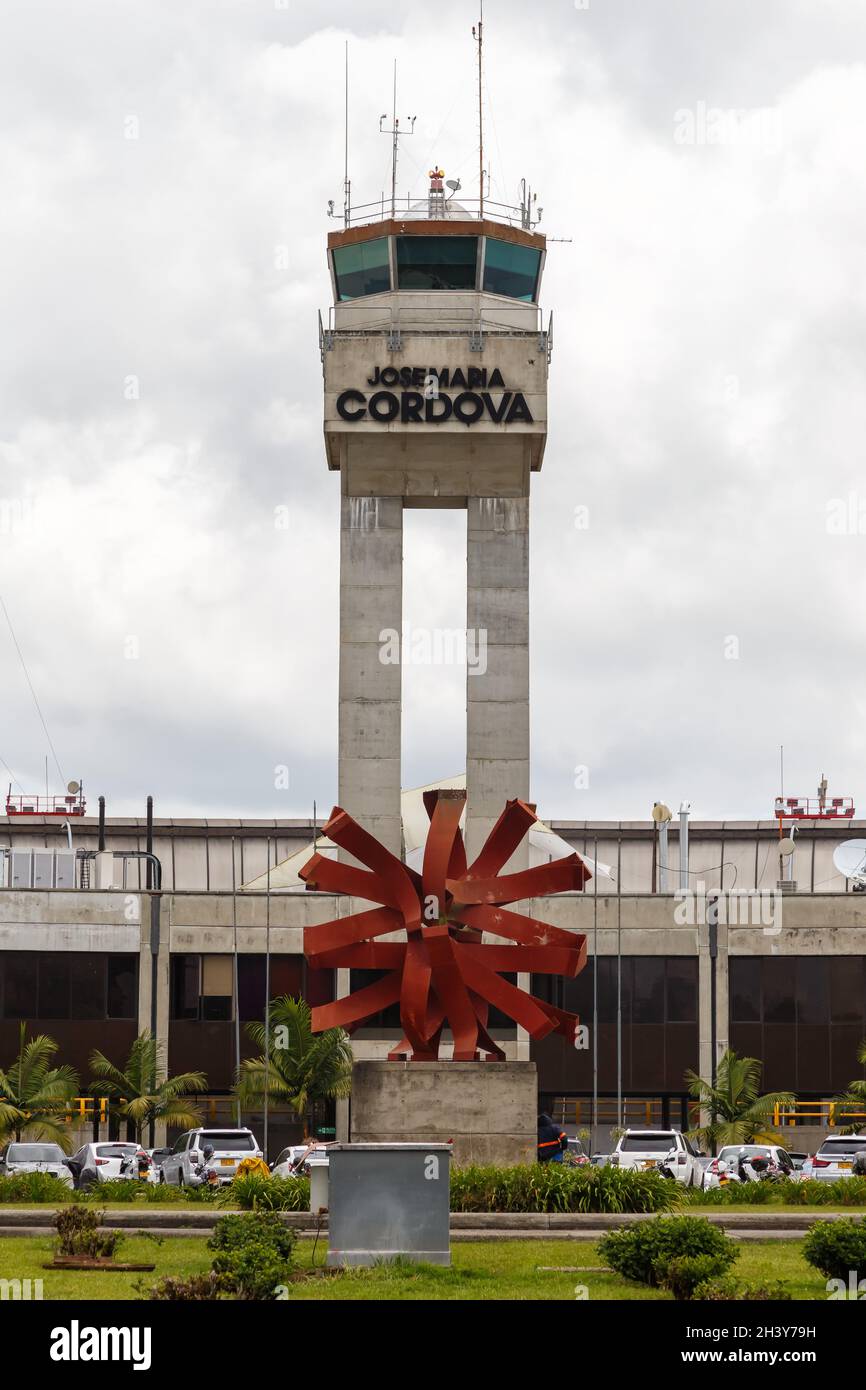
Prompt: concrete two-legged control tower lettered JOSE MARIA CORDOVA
<box><xmin>320</xmin><ymin>168</ymin><xmax>552</xmax><ymax>867</ymax></box>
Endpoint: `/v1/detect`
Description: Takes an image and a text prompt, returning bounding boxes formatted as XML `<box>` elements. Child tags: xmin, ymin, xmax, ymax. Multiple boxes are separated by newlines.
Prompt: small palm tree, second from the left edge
<box><xmin>90</xmin><ymin>1030</ymin><xmax>207</xmax><ymax>1144</ymax></box>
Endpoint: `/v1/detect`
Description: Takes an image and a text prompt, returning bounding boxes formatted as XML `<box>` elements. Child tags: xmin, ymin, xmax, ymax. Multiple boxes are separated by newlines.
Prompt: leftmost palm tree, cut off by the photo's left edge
<box><xmin>0</xmin><ymin>1023</ymin><xmax>78</xmax><ymax>1154</ymax></box>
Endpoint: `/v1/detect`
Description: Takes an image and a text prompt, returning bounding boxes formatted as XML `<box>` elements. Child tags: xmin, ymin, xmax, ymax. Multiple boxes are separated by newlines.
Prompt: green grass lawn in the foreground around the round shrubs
<box><xmin>0</xmin><ymin>1233</ymin><xmax>827</xmax><ymax>1301</ymax></box>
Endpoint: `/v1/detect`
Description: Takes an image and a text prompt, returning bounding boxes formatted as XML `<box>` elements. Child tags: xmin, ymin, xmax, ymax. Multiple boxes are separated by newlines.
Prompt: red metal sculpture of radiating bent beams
<box><xmin>300</xmin><ymin>791</ymin><xmax>591</xmax><ymax>1062</ymax></box>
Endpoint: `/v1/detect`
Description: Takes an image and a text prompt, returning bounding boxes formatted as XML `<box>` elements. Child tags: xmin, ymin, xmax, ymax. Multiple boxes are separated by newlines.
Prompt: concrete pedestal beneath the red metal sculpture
<box><xmin>350</xmin><ymin>1062</ymin><xmax>538</xmax><ymax>1168</ymax></box>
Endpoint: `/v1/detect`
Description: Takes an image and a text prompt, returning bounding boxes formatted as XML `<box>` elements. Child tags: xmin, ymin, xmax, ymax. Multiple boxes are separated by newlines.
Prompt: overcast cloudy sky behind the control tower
<box><xmin>0</xmin><ymin>0</ymin><xmax>866</xmax><ymax>820</ymax></box>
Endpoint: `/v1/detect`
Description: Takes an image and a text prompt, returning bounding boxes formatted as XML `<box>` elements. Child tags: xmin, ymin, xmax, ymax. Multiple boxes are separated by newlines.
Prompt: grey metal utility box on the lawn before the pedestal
<box><xmin>328</xmin><ymin>1144</ymin><xmax>450</xmax><ymax>1266</ymax></box>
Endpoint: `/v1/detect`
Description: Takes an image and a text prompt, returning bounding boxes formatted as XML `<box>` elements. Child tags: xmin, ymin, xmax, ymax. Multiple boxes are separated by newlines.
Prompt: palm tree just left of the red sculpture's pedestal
<box><xmin>235</xmin><ymin>994</ymin><xmax>352</xmax><ymax>1123</ymax></box>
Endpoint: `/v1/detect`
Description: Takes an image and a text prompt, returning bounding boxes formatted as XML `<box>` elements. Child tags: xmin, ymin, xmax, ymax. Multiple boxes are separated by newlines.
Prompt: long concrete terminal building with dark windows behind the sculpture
<box><xmin>0</xmin><ymin>816</ymin><xmax>866</xmax><ymax>1147</ymax></box>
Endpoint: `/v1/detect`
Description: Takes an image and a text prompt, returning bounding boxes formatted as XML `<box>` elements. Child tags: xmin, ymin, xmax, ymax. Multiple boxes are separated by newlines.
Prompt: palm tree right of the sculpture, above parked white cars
<box><xmin>685</xmin><ymin>1048</ymin><xmax>794</xmax><ymax>1154</ymax></box>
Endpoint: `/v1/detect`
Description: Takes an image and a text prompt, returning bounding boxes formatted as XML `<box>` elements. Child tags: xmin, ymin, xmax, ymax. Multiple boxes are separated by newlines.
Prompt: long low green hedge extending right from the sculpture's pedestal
<box><xmin>450</xmin><ymin>1163</ymin><xmax>678</xmax><ymax>1213</ymax></box>
